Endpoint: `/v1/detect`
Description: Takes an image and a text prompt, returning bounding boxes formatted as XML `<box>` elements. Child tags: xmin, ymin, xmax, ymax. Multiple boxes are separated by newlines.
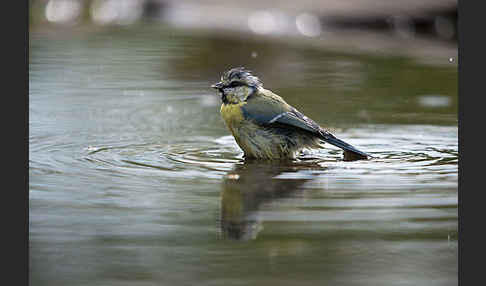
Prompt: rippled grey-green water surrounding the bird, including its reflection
<box><xmin>29</xmin><ymin>25</ymin><xmax>458</xmax><ymax>285</ymax></box>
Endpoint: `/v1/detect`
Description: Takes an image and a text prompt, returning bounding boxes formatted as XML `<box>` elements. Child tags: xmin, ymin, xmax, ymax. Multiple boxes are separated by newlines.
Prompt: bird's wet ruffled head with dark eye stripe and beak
<box><xmin>211</xmin><ymin>67</ymin><xmax>263</xmax><ymax>104</ymax></box>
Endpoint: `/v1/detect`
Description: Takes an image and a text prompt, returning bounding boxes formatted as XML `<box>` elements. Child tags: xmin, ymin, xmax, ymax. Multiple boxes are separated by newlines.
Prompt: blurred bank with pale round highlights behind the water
<box><xmin>29</xmin><ymin>0</ymin><xmax>457</xmax><ymax>63</ymax></box>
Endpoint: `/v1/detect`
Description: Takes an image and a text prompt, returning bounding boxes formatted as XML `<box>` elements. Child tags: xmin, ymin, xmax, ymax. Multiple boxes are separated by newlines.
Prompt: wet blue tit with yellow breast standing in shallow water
<box><xmin>211</xmin><ymin>67</ymin><xmax>371</xmax><ymax>160</ymax></box>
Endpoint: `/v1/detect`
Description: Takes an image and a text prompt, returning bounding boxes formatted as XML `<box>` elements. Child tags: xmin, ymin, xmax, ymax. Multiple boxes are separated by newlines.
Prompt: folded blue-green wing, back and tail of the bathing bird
<box><xmin>241</xmin><ymin>91</ymin><xmax>370</xmax><ymax>157</ymax></box>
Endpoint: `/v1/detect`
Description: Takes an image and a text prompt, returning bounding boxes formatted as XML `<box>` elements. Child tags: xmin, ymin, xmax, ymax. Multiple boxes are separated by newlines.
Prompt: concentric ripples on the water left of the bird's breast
<box><xmin>82</xmin><ymin>136</ymin><xmax>242</xmax><ymax>178</ymax></box>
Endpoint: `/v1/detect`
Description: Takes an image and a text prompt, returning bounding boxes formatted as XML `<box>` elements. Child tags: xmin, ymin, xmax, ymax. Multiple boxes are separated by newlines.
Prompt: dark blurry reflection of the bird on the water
<box><xmin>220</xmin><ymin>161</ymin><xmax>323</xmax><ymax>240</ymax></box>
